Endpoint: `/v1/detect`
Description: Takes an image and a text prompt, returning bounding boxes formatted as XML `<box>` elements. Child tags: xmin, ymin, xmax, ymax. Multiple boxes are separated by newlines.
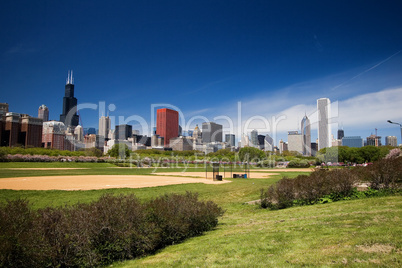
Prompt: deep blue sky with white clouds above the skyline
<box><xmin>0</xmin><ymin>0</ymin><xmax>402</xmax><ymax>143</ymax></box>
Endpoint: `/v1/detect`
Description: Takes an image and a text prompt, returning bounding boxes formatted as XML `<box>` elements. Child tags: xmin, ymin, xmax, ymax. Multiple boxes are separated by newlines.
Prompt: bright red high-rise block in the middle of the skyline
<box><xmin>156</xmin><ymin>108</ymin><xmax>179</xmax><ymax>147</ymax></box>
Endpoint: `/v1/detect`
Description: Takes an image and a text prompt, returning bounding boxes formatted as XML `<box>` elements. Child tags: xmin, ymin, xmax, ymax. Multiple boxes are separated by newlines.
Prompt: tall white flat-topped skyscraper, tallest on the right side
<box><xmin>317</xmin><ymin>98</ymin><xmax>331</xmax><ymax>150</ymax></box>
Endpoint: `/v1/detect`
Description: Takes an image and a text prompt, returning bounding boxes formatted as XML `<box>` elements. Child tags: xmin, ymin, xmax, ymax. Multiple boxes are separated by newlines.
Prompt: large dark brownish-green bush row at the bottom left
<box><xmin>0</xmin><ymin>193</ymin><xmax>223</xmax><ymax>267</ymax></box>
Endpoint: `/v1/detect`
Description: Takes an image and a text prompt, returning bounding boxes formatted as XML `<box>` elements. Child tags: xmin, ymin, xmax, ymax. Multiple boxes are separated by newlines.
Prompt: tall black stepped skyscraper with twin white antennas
<box><xmin>60</xmin><ymin>71</ymin><xmax>78</xmax><ymax>127</ymax></box>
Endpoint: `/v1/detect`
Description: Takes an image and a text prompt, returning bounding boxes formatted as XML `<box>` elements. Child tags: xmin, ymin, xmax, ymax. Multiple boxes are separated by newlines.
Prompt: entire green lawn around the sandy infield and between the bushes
<box><xmin>0</xmin><ymin>163</ymin><xmax>402</xmax><ymax>267</ymax></box>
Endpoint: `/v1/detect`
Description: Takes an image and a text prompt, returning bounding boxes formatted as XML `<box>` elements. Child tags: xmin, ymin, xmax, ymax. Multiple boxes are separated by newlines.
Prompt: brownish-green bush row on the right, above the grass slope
<box><xmin>260</xmin><ymin>157</ymin><xmax>402</xmax><ymax>209</ymax></box>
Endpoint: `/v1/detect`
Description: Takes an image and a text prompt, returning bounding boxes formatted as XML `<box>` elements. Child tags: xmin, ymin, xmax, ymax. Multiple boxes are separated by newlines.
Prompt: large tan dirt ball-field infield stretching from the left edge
<box><xmin>0</xmin><ymin>175</ymin><xmax>230</xmax><ymax>191</ymax></box>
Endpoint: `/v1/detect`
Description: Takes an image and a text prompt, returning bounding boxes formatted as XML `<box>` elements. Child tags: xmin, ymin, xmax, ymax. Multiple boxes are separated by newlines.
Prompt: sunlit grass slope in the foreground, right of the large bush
<box><xmin>113</xmin><ymin>196</ymin><xmax>402</xmax><ymax>267</ymax></box>
